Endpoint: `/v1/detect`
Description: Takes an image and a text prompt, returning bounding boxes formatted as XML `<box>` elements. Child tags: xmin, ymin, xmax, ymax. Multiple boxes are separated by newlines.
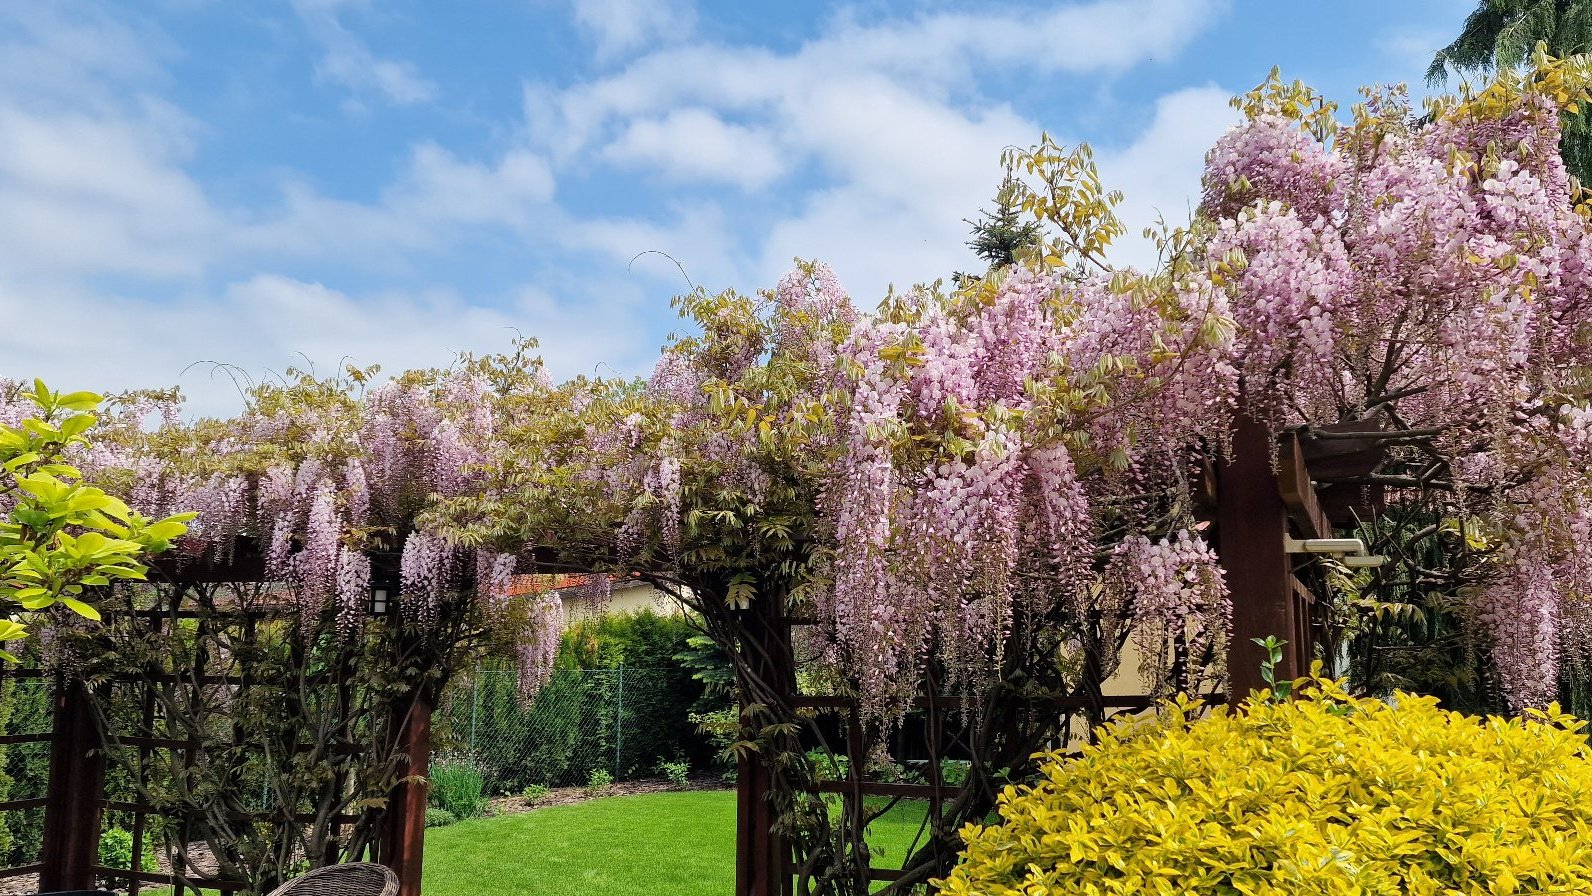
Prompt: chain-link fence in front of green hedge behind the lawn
<box><xmin>435</xmin><ymin>667</ymin><xmax>712</xmax><ymax>794</ymax></box>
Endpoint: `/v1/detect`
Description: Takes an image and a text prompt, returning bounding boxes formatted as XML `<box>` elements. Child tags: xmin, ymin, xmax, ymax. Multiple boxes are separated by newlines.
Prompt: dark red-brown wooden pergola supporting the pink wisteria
<box><xmin>0</xmin><ymin>410</ymin><xmax>1385</xmax><ymax>896</ymax></box>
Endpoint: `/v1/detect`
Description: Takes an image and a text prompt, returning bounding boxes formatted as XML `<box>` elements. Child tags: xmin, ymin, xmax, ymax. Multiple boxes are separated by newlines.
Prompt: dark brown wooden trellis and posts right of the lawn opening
<box><xmin>736</xmin><ymin>415</ymin><xmax>1387</xmax><ymax>896</ymax></box>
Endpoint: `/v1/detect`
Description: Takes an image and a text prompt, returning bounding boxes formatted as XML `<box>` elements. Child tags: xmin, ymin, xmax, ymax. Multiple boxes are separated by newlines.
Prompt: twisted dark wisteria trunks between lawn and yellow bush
<box><xmin>677</xmin><ymin>578</ymin><xmax>1121</xmax><ymax>896</ymax></box>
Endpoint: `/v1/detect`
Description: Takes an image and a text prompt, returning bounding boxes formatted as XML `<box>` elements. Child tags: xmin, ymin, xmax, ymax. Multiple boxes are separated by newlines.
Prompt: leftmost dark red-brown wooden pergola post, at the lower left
<box><xmin>38</xmin><ymin>678</ymin><xmax>105</xmax><ymax>893</ymax></box>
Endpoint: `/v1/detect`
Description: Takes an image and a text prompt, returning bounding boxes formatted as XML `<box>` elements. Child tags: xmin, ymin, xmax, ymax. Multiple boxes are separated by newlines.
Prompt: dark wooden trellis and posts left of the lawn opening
<box><xmin>0</xmin><ymin>555</ymin><xmax>433</xmax><ymax>896</ymax></box>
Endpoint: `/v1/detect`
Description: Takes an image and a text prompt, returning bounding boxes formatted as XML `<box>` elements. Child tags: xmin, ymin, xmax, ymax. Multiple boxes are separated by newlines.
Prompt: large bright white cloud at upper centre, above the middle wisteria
<box><xmin>527</xmin><ymin>0</ymin><xmax>1227</xmax><ymax>302</ymax></box>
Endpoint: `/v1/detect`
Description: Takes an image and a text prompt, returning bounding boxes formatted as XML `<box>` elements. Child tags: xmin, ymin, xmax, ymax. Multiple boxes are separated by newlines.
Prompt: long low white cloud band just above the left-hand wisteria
<box><xmin>0</xmin><ymin>274</ymin><xmax>654</xmax><ymax>415</ymax></box>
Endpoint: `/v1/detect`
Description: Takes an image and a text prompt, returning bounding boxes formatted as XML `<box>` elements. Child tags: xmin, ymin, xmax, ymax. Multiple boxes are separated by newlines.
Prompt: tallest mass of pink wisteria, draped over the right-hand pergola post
<box><xmin>1205</xmin><ymin>70</ymin><xmax>1592</xmax><ymax>708</ymax></box>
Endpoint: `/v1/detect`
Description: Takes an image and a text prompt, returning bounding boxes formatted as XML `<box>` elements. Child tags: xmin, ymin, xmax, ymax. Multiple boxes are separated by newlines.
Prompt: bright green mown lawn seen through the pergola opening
<box><xmin>423</xmin><ymin>791</ymin><xmax>923</xmax><ymax>896</ymax></box>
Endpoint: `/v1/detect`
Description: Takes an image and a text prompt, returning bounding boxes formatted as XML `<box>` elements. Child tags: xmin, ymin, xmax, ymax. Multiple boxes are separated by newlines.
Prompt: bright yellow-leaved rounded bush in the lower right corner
<box><xmin>944</xmin><ymin>680</ymin><xmax>1592</xmax><ymax>896</ymax></box>
